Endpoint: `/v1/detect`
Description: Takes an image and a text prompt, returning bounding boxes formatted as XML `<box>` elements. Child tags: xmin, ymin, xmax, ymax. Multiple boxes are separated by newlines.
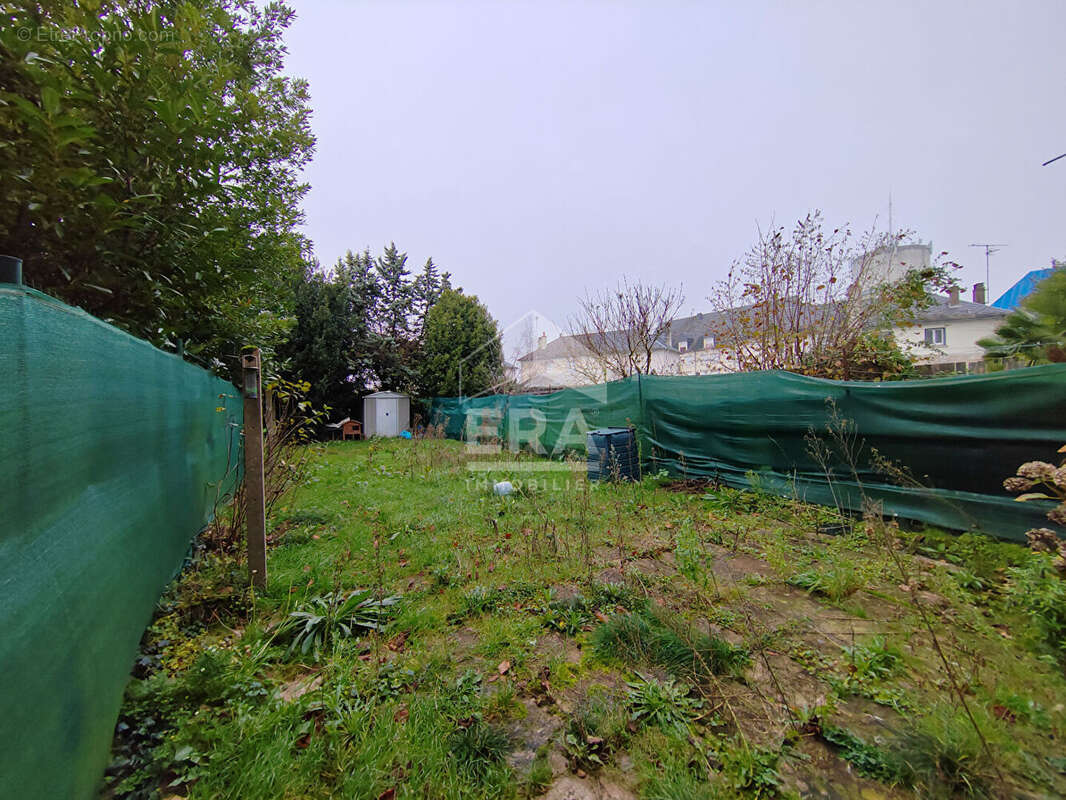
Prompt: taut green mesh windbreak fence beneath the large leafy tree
<box><xmin>0</xmin><ymin>285</ymin><xmax>242</xmax><ymax>800</ymax></box>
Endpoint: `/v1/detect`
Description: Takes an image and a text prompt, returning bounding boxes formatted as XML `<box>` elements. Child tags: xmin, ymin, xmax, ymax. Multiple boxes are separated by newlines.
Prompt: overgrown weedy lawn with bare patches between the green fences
<box><xmin>103</xmin><ymin>441</ymin><xmax>1066</xmax><ymax>800</ymax></box>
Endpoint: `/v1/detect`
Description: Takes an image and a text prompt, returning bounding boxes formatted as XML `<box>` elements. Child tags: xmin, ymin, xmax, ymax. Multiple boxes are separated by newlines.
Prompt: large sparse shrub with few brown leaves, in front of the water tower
<box><xmin>708</xmin><ymin>211</ymin><xmax>955</xmax><ymax>379</ymax></box>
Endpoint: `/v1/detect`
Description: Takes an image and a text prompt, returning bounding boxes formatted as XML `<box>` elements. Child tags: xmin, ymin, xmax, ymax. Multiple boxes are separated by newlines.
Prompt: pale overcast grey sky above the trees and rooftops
<box><xmin>287</xmin><ymin>0</ymin><xmax>1066</xmax><ymax>341</ymax></box>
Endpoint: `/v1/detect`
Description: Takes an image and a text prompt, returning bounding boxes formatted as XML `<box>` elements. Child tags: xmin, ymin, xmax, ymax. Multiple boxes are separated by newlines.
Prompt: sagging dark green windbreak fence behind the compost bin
<box><xmin>430</xmin><ymin>365</ymin><xmax>1066</xmax><ymax>541</ymax></box>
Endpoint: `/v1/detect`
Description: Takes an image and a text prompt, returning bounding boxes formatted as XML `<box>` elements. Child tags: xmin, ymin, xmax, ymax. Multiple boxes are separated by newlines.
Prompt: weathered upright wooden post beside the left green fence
<box><xmin>241</xmin><ymin>348</ymin><xmax>267</xmax><ymax>589</ymax></box>
